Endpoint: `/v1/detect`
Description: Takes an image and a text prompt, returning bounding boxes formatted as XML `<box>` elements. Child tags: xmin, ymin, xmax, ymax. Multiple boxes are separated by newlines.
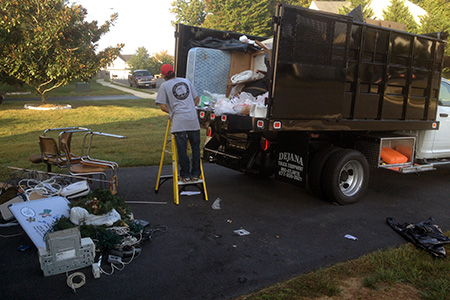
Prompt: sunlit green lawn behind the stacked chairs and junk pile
<box><xmin>0</xmin><ymin>100</ymin><xmax>168</xmax><ymax>181</ymax></box>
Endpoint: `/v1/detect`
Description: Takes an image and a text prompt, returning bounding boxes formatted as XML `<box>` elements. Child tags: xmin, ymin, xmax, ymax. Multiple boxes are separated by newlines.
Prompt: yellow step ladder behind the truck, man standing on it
<box><xmin>155</xmin><ymin>119</ymin><xmax>208</xmax><ymax>204</ymax></box>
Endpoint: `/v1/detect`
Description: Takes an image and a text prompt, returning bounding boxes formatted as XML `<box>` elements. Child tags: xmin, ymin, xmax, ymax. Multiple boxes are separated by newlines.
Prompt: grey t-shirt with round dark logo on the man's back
<box><xmin>155</xmin><ymin>77</ymin><xmax>200</xmax><ymax>133</ymax></box>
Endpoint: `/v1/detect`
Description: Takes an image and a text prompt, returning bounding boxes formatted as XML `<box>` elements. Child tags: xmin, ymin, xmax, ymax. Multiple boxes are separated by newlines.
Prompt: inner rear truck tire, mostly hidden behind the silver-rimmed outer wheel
<box><xmin>308</xmin><ymin>146</ymin><xmax>341</xmax><ymax>199</ymax></box>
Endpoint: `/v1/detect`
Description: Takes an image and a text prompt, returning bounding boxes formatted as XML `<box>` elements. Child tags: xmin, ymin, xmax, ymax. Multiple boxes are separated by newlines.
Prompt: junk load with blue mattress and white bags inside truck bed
<box><xmin>186</xmin><ymin>35</ymin><xmax>272</xmax><ymax>117</ymax></box>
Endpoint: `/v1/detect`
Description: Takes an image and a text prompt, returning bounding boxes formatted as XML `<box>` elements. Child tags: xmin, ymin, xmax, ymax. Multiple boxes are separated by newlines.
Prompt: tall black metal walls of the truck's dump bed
<box><xmin>176</xmin><ymin>5</ymin><xmax>446</xmax><ymax>131</ymax></box>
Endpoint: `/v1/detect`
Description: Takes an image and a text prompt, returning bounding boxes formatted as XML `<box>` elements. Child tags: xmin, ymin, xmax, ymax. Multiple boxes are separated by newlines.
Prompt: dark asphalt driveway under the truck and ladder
<box><xmin>0</xmin><ymin>163</ymin><xmax>450</xmax><ymax>300</ymax></box>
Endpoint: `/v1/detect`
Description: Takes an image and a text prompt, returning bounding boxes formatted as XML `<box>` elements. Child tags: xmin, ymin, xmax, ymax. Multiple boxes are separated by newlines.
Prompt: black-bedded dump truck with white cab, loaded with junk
<box><xmin>175</xmin><ymin>4</ymin><xmax>450</xmax><ymax>204</ymax></box>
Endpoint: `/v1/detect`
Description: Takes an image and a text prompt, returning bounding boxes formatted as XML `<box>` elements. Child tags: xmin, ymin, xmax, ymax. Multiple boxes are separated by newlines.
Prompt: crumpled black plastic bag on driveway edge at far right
<box><xmin>386</xmin><ymin>217</ymin><xmax>450</xmax><ymax>257</ymax></box>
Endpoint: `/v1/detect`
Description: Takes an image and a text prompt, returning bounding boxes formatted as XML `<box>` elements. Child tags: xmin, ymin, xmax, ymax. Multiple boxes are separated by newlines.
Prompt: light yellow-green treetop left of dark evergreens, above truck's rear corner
<box><xmin>170</xmin><ymin>0</ymin><xmax>206</xmax><ymax>26</ymax></box>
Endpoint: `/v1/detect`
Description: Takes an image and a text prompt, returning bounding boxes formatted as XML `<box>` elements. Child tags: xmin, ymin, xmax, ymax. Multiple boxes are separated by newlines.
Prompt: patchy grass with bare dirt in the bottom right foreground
<box><xmin>237</xmin><ymin>241</ymin><xmax>450</xmax><ymax>300</ymax></box>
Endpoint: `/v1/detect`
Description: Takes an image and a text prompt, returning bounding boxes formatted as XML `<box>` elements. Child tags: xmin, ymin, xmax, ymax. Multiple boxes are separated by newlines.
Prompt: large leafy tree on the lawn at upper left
<box><xmin>0</xmin><ymin>0</ymin><xmax>123</xmax><ymax>103</ymax></box>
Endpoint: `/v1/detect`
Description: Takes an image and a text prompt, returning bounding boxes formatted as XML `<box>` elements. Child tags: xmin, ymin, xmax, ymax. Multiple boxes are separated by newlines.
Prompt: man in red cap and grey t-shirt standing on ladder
<box><xmin>156</xmin><ymin>64</ymin><xmax>200</xmax><ymax>182</ymax></box>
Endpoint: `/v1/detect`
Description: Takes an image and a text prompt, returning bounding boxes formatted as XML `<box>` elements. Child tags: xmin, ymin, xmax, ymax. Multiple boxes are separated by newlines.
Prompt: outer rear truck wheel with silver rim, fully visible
<box><xmin>322</xmin><ymin>149</ymin><xmax>369</xmax><ymax>204</ymax></box>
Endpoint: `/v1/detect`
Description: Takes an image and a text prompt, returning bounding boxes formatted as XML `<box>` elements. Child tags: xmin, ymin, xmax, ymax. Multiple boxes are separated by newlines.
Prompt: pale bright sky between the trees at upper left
<box><xmin>70</xmin><ymin>0</ymin><xmax>175</xmax><ymax>55</ymax></box>
